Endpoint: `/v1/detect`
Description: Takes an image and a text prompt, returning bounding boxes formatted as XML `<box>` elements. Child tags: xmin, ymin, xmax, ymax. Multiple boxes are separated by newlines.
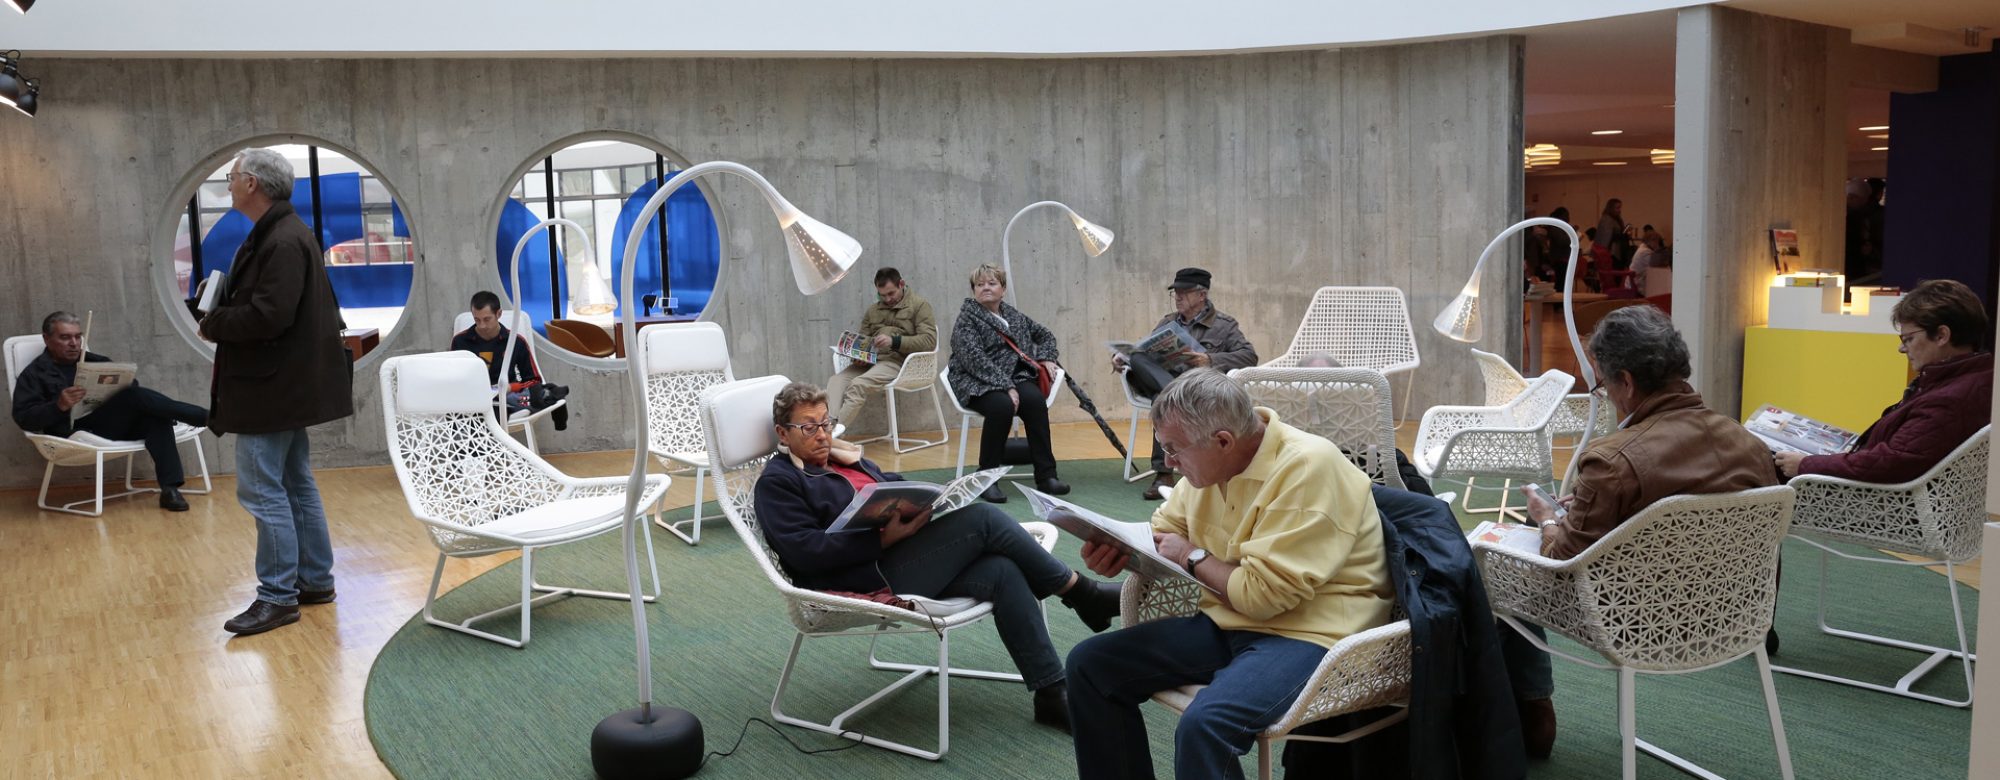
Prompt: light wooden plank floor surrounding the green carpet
<box><xmin>0</xmin><ymin>420</ymin><xmax>1978</xmax><ymax>778</ymax></box>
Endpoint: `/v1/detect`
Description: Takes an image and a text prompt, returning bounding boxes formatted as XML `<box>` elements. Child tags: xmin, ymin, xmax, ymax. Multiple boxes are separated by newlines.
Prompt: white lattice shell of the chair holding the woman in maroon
<box><xmin>1792</xmin><ymin>426</ymin><xmax>1992</xmax><ymax>564</ymax></box>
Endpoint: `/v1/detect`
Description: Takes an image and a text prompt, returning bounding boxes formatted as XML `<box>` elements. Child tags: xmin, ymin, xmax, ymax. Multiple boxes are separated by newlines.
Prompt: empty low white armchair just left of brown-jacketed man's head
<box><xmin>1410</xmin><ymin>370</ymin><xmax>1576</xmax><ymax>514</ymax></box>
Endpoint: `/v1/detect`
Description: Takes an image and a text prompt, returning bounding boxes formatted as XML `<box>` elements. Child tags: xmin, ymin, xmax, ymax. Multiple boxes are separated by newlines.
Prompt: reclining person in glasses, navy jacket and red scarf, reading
<box><xmin>756</xmin><ymin>382</ymin><xmax>1118</xmax><ymax>730</ymax></box>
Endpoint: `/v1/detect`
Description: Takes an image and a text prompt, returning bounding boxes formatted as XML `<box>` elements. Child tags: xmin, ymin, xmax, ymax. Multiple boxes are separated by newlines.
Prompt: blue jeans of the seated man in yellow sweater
<box><xmin>1068</xmin><ymin>614</ymin><xmax>1326</xmax><ymax>780</ymax></box>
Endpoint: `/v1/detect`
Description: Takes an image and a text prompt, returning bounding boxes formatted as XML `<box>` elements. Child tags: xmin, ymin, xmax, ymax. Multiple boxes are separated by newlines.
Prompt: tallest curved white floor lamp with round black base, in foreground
<box><xmin>590</xmin><ymin>162</ymin><xmax>862</xmax><ymax>780</ymax></box>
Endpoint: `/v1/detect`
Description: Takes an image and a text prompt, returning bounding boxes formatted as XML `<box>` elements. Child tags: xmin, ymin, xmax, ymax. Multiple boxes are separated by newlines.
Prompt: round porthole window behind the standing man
<box><xmin>170</xmin><ymin>136</ymin><xmax>418</xmax><ymax>360</ymax></box>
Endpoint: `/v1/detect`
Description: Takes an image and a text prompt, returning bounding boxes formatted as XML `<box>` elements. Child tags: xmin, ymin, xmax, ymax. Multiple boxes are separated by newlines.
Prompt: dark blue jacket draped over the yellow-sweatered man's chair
<box><xmin>1284</xmin><ymin>486</ymin><xmax>1528</xmax><ymax>780</ymax></box>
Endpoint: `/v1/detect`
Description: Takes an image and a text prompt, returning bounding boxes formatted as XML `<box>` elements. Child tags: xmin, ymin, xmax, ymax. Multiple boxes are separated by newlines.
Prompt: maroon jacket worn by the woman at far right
<box><xmin>1798</xmin><ymin>352</ymin><xmax>1994</xmax><ymax>484</ymax></box>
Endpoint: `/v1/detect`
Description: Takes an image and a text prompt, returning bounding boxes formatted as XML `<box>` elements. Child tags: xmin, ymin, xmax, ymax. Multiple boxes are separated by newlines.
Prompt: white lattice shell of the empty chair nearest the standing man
<box><xmin>382</xmin><ymin>352</ymin><xmax>566</xmax><ymax>554</ymax></box>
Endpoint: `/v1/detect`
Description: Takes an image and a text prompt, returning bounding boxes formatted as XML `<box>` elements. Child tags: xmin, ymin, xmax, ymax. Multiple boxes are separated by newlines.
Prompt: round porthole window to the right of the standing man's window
<box><xmin>494</xmin><ymin>134</ymin><xmax>722</xmax><ymax>358</ymax></box>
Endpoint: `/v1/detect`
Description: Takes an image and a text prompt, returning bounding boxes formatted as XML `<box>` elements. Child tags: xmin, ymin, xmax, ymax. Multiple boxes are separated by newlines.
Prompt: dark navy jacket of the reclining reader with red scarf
<box><xmin>756</xmin><ymin>452</ymin><xmax>902</xmax><ymax>594</ymax></box>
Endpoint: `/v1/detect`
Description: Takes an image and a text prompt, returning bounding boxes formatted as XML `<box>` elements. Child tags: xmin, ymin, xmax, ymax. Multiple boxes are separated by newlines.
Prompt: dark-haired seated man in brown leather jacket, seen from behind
<box><xmin>1500</xmin><ymin>306</ymin><xmax>1778</xmax><ymax>758</ymax></box>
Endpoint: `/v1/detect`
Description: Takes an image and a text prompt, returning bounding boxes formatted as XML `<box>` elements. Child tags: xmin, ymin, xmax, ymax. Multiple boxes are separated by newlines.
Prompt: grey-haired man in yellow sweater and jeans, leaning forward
<box><xmin>1068</xmin><ymin>368</ymin><xmax>1394</xmax><ymax>780</ymax></box>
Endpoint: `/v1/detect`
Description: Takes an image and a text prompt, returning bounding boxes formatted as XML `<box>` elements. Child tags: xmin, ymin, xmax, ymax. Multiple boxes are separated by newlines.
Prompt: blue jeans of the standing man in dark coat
<box><xmin>236</xmin><ymin>428</ymin><xmax>334</xmax><ymax>606</ymax></box>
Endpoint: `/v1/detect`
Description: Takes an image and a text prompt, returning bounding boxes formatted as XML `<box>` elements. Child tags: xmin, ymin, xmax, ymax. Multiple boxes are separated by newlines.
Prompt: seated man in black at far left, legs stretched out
<box><xmin>14</xmin><ymin>312</ymin><xmax>208</xmax><ymax>512</ymax></box>
